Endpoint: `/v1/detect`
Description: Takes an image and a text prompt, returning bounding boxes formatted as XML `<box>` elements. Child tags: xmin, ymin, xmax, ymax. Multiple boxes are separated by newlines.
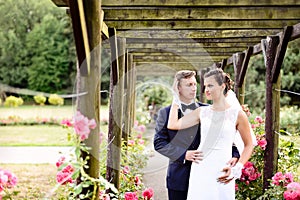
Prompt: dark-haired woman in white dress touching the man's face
<box><xmin>168</xmin><ymin>68</ymin><xmax>253</xmax><ymax>200</ymax></box>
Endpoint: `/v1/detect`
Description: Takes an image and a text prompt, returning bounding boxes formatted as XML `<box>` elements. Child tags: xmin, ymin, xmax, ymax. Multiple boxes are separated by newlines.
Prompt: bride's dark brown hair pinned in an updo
<box><xmin>204</xmin><ymin>68</ymin><xmax>234</xmax><ymax>95</ymax></box>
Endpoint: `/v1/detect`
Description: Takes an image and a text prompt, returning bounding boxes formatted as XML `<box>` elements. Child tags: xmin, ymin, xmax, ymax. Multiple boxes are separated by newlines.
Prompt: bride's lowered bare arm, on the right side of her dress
<box><xmin>237</xmin><ymin>110</ymin><xmax>253</xmax><ymax>165</ymax></box>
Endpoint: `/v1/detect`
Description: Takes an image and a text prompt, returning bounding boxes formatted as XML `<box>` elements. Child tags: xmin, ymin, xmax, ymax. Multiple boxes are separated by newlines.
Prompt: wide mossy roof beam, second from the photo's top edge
<box><xmin>102</xmin><ymin>6</ymin><xmax>300</xmax><ymax>22</ymax></box>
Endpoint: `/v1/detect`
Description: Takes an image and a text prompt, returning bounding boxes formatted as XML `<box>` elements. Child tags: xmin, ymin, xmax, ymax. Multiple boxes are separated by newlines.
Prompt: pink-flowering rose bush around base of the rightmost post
<box><xmin>236</xmin><ymin>110</ymin><xmax>299</xmax><ymax>200</ymax></box>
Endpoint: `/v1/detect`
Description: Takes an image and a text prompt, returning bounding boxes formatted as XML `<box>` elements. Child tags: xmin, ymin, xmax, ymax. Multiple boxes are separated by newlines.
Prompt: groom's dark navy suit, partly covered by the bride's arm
<box><xmin>154</xmin><ymin>103</ymin><xmax>240</xmax><ymax>200</ymax></box>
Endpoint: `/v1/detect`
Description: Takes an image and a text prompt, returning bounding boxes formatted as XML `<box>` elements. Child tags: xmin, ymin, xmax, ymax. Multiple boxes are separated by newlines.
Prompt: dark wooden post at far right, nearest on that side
<box><xmin>261</xmin><ymin>36</ymin><xmax>279</xmax><ymax>189</ymax></box>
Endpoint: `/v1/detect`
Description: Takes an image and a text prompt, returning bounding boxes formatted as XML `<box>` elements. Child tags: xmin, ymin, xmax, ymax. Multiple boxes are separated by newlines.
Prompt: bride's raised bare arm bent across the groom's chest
<box><xmin>168</xmin><ymin>103</ymin><xmax>200</xmax><ymax>130</ymax></box>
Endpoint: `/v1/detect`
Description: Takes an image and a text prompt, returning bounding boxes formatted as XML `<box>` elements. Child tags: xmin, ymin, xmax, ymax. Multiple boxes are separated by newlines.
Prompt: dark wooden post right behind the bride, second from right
<box><xmin>233</xmin><ymin>53</ymin><xmax>245</xmax><ymax>102</ymax></box>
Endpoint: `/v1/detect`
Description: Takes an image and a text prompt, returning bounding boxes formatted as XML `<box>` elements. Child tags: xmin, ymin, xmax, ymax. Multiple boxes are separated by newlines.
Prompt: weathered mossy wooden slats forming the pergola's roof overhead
<box><xmin>102</xmin><ymin>0</ymin><xmax>300</xmax><ymax>75</ymax></box>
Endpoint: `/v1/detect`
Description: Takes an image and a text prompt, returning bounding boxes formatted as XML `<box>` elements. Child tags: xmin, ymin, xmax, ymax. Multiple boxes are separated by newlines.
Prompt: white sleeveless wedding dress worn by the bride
<box><xmin>187</xmin><ymin>106</ymin><xmax>241</xmax><ymax>200</ymax></box>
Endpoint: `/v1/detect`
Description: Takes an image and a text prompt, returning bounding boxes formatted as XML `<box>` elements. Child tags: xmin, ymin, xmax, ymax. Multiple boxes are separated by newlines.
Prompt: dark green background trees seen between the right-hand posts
<box><xmin>245</xmin><ymin>40</ymin><xmax>300</xmax><ymax>110</ymax></box>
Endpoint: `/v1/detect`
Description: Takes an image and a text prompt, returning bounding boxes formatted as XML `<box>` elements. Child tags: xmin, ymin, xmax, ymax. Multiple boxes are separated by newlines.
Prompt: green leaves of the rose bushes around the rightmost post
<box><xmin>236</xmin><ymin>114</ymin><xmax>300</xmax><ymax>200</ymax></box>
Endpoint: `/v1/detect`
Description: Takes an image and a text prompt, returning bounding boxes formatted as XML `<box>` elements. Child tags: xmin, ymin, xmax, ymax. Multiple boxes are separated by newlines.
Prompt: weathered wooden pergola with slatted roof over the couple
<box><xmin>52</xmin><ymin>0</ymin><xmax>300</xmax><ymax>197</ymax></box>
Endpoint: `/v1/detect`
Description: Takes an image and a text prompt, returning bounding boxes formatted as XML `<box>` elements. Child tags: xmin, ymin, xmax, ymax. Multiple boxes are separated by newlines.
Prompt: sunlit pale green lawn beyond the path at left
<box><xmin>0</xmin><ymin>106</ymin><xmax>108</xmax><ymax>146</ymax></box>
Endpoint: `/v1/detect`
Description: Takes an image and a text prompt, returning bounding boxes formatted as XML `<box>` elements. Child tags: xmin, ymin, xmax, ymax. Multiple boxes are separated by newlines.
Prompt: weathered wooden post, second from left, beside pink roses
<box><xmin>106</xmin><ymin>28</ymin><xmax>125</xmax><ymax>189</ymax></box>
